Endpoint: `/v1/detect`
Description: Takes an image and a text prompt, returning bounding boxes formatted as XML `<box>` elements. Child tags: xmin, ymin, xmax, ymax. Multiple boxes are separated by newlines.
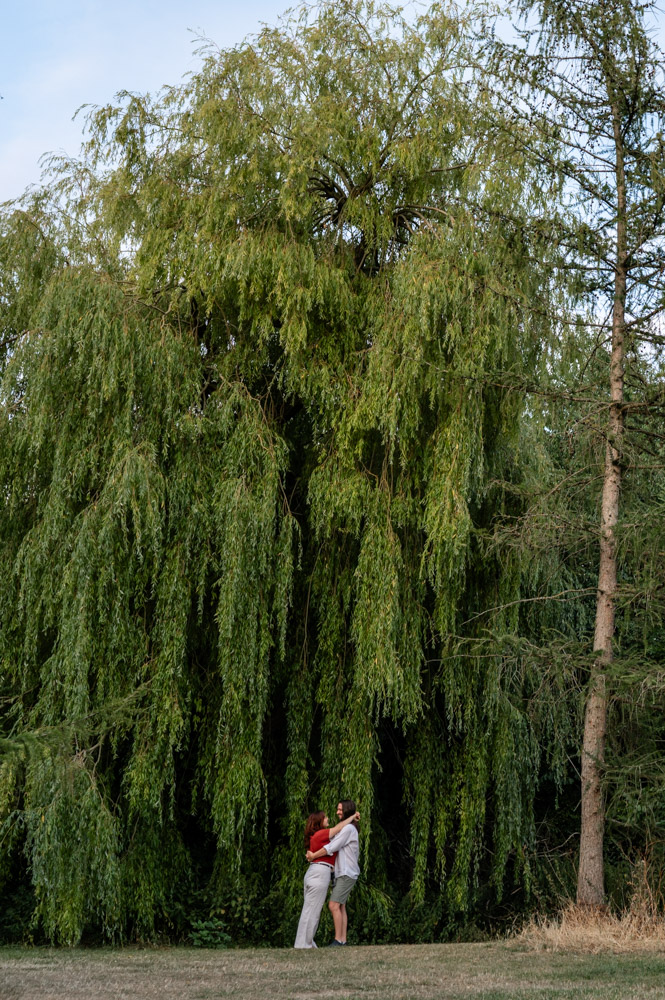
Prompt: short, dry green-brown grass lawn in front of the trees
<box><xmin>0</xmin><ymin>942</ymin><xmax>665</xmax><ymax>1000</ymax></box>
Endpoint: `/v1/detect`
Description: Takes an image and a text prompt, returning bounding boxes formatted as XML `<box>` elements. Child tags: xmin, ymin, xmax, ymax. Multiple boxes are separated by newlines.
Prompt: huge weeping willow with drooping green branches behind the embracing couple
<box><xmin>0</xmin><ymin>2</ymin><xmax>571</xmax><ymax>942</ymax></box>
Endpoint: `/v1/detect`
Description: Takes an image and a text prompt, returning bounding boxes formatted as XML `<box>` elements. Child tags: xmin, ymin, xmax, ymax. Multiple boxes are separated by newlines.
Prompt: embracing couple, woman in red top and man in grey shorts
<box><xmin>293</xmin><ymin>799</ymin><xmax>360</xmax><ymax>948</ymax></box>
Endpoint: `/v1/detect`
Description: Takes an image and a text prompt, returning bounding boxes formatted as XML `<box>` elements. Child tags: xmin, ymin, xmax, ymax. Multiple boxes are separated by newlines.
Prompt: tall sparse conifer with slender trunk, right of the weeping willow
<box><xmin>486</xmin><ymin>0</ymin><xmax>665</xmax><ymax>905</ymax></box>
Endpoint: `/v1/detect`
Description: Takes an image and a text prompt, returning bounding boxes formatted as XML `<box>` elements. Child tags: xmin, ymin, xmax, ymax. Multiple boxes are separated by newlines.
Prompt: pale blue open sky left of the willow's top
<box><xmin>0</xmin><ymin>0</ymin><xmax>293</xmax><ymax>202</ymax></box>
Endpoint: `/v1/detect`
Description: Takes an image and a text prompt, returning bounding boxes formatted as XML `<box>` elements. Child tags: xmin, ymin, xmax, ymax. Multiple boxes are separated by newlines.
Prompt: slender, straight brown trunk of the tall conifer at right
<box><xmin>577</xmin><ymin>95</ymin><xmax>627</xmax><ymax>906</ymax></box>
